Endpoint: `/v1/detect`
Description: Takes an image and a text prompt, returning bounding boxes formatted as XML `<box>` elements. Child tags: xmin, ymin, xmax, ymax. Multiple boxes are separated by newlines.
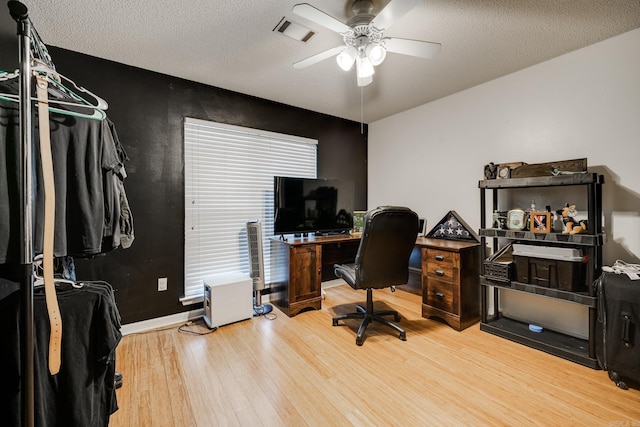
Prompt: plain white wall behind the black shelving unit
<box><xmin>368</xmin><ymin>29</ymin><xmax>640</xmax><ymax>335</ymax></box>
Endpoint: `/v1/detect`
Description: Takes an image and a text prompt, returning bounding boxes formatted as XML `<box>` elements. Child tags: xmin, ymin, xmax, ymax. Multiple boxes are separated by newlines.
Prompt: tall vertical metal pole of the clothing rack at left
<box><xmin>7</xmin><ymin>1</ymin><xmax>35</xmax><ymax>427</ymax></box>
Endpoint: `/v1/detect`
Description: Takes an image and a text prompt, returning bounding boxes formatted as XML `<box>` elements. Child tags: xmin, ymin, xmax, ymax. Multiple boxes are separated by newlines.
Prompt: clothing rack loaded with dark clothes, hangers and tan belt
<box><xmin>0</xmin><ymin>5</ymin><xmax>133</xmax><ymax>426</ymax></box>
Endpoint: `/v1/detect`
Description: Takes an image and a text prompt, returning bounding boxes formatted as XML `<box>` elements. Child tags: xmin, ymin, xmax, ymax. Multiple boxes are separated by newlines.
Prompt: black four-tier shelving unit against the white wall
<box><xmin>478</xmin><ymin>173</ymin><xmax>605</xmax><ymax>369</ymax></box>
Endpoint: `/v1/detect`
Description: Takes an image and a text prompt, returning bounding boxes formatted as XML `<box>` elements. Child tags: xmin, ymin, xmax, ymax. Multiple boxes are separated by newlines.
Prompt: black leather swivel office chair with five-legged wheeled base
<box><xmin>333</xmin><ymin>206</ymin><xmax>418</xmax><ymax>345</ymax></box>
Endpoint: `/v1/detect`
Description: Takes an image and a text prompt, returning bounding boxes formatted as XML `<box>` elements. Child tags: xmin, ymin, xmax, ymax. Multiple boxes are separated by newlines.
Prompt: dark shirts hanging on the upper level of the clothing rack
<box><xmin>0</xmin><ymin>101</ymin><xmax>133</xmax><ymax>264</ymax></box>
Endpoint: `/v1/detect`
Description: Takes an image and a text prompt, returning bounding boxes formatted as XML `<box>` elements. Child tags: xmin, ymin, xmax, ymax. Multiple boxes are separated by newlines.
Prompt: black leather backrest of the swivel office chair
<box><xmin>355</xmin><ymin>206</ymin><xmax>419</xmax><ymax>289</ymax></box>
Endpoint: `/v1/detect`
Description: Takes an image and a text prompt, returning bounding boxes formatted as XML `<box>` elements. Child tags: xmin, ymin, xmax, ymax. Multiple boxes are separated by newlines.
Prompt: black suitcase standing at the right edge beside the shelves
<box><xmin>594</xmin><ymin>272</ymin><xmax>640</xmax><ymax>389</ymax></box>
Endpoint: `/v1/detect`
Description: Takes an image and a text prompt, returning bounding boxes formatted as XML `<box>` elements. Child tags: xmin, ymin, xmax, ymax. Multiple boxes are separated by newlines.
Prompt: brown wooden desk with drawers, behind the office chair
<box><xmin>269</xmin><ymin>235</ymin><xmax>480</xmax><ymax>330</ymax></box>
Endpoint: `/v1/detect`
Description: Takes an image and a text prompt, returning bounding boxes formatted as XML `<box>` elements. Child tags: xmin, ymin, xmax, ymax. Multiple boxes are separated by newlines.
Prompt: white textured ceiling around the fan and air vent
<box><xmin>0</xmin><ymin>0</ymin><xmax>640</xmax><ymax>123</ymax></box>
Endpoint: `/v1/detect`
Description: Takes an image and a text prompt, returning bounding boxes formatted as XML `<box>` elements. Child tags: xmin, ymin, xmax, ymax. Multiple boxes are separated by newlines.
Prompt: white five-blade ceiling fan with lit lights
<box><xmin>292</xmin><ymin>0</ymin><xmax>442</xmax><ymax>86</ymax></box>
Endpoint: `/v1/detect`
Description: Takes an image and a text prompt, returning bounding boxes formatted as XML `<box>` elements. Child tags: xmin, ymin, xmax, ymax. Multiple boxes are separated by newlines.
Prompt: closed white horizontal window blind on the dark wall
<box><xmin>182</xmin><ymin>118</ymin><xmax>317</xmax><ymax>304</ymax></box>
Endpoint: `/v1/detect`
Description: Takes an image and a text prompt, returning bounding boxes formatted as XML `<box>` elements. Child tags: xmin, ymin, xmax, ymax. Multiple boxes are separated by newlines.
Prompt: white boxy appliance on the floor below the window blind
<box><xmin>203</xmin><ymin>273</ymin><xmax>253</xmax><ymax>328</ymax></box>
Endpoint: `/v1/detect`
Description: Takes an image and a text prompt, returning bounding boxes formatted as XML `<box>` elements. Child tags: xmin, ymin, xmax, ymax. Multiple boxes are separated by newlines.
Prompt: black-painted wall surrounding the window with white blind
<box><xmin>0</xmin><ymin>39</ymin><xmax>367</xmax><ymax>323</ymax></box>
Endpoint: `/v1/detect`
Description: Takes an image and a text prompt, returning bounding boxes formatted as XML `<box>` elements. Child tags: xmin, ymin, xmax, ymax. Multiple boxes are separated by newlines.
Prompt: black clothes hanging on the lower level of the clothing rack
<box><xmin>0</xmin><ymin>282</ymin><xmax>121</xmax><ymax>427</ymax></box>
